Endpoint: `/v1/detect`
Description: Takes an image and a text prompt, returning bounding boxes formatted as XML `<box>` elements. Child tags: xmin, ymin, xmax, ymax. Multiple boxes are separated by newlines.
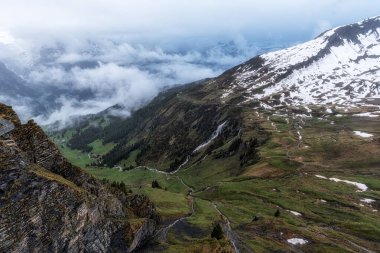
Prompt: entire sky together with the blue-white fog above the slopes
<box><xmin>0</xmin><ymin>0</ymin><xmax>380</xmax><ymax>124</ymax></box>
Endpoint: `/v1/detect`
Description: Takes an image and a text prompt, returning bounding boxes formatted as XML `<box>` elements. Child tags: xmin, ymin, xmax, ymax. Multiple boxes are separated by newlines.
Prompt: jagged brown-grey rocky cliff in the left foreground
<box><xmin>0</xmin><ymin>104</ymin><xmax>158</xmax><ymax>252</ymax></box>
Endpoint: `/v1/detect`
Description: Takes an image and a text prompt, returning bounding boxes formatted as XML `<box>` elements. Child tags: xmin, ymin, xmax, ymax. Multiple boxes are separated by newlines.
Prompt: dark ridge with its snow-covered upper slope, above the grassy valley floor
<box><xmin>59</xmin><ymin>18</ymin><xmax>380</xmax><ymax>169</ymax></box>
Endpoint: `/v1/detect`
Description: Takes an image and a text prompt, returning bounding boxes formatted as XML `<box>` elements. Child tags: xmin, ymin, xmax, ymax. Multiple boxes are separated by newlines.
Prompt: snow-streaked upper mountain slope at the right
<box><xmin>221</xmin><ymin>17</ymin><xmax>380</xmax><ymax>107</ymax></box>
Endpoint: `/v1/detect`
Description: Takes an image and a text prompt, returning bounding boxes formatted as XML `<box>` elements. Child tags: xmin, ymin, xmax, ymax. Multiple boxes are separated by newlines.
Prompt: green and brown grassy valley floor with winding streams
<box><xmin>54</xmin><ymin>111</ymin><xmax>380</xmax><ymax>252</ymax></box>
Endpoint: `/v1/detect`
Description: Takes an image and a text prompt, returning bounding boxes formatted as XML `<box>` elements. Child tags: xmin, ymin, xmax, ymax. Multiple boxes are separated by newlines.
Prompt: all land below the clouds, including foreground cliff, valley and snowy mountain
<box><xmin>0</xmin><ymin>17</ymin><xmax>380</xmax><ymax>252</ymax></box>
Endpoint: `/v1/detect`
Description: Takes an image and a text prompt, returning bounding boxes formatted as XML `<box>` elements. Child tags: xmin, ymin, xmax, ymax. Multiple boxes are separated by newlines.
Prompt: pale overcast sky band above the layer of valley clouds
<box><xmin>0</xmin><ymin>0</ymin><xmax>380</xmax><ymax>48</ymax></box>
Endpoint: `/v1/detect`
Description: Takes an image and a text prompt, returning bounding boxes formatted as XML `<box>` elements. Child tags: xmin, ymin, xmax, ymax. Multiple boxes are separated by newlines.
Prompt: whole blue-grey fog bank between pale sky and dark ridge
<box><xmin>1</xmin><ymin>35</ymin><xmax>267</xmax><ymax>124</ymax></box>
